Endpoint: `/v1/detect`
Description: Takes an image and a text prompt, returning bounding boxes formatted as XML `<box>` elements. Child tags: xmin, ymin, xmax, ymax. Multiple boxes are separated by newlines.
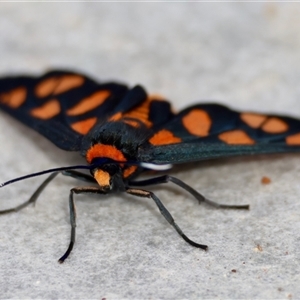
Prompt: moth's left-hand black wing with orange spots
<box><xmin>0</xmin><ymin>71</ymin><xmax>146</xmax><ymax>151</ymax></box>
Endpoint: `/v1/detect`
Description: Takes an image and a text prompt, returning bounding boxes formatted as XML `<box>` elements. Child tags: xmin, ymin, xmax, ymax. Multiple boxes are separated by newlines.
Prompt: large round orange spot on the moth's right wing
<box><xmin>182</xmin><ymin>109</ymin><xmax>212</xmax><ymax>137</ymax></box>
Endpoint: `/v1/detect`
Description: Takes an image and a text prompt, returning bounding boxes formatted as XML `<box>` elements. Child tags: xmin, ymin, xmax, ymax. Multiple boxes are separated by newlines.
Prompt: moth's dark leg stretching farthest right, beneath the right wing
<box><xmin>129</xmin><ymin>175</ymin><xmax>249</xmax><ymax>209</ymax></box>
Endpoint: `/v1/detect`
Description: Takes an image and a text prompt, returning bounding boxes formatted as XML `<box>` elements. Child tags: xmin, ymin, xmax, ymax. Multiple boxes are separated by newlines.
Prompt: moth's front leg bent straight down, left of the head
<box><xmin>58</xmin><ymin>187</ymin><xmax>105</xmax><ymax>264</ymax></box>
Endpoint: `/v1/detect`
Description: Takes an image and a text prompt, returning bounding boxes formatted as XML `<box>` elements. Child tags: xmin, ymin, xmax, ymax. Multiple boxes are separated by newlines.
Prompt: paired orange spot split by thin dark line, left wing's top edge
<box><xmin>35</xmin><ymin>75</ymin><xmax>84</xmax><ymax>98</ymax></box>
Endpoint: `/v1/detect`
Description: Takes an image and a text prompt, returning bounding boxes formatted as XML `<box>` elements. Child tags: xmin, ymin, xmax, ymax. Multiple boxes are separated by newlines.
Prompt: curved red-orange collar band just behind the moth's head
<box><xmin>86</xmin><ymin>144</ymin><xmax>126</xmax><ymax>163</ymax></box>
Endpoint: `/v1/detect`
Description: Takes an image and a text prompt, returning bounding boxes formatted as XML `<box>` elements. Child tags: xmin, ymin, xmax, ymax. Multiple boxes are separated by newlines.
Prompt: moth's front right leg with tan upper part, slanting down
<box><xmin>126</xmin><ymin>188</ymin><xmax>208</xmax><ymax>250</ymax></box>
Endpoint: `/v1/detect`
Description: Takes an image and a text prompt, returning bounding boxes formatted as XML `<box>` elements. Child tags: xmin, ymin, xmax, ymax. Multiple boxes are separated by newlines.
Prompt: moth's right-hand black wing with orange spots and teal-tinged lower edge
<box><xmin>139</xmin><ymin>104</ymin><xmax>300</xmax><ymax>163</ymax></box>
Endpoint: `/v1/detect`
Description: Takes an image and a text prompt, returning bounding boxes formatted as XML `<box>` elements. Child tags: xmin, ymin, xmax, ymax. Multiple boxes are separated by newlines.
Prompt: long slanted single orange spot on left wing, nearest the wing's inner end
<box><xmin>67</xmin><ymin>90</ymin><xmax>111</xmax><ymax>116</ymax></box>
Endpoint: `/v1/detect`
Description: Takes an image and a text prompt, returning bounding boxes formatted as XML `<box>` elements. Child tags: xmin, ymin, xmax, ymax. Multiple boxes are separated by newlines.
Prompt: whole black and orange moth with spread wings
<box><xmin>0</xmin><ymin>71</ymin><xmax>300</xmax><ymax>263</ymax></box>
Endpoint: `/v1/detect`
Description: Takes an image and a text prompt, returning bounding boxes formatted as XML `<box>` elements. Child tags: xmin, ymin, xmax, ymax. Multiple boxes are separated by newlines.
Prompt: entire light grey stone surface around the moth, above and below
<box><xmin>0</xmin><ymin>3</ymin><xmax>300</xmax><ymax>300</ymax></box>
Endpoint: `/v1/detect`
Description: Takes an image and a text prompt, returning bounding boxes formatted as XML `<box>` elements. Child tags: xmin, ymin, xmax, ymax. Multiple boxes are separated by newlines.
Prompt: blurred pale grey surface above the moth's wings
<box><xmin>0</xmin><ymin>2</ymin><xmax>300</xmax><ymax>112</ymax></box>
